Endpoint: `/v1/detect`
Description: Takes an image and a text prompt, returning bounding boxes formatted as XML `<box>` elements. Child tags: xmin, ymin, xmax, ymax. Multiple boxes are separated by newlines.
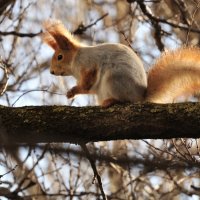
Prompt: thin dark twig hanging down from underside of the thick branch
<box><xmin>80</xmin><ymin>143</ymin><xmax>107</xmax><ymax>200</ymax></box>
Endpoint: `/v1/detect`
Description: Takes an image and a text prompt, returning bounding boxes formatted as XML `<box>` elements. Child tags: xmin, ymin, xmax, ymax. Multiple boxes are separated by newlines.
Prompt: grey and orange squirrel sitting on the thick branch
<box><xmin>42</xmin><ymin>20</ymin><xmax>200</xmax><ymax>107</ymax></box>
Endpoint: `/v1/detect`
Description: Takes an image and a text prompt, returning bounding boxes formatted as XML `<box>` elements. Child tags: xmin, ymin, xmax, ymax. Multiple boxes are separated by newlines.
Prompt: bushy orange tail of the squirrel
<box><xmin>146</xmin><ymin>47</ymin><xmax>200</xmax><ymax>103</ymax></box>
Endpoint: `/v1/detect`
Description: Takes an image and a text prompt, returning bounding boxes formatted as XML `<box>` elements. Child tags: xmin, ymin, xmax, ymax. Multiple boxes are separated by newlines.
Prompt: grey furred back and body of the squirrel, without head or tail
<box><xmin>72</xmin><ymin>44</ymin><xmax>147</xmax><ymax>104</ymax></box>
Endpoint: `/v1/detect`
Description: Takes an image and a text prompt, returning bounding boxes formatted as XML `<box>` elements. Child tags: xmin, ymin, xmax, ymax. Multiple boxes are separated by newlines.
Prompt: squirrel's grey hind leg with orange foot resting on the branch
<box><xmin>97</xmin><ymin>68</ymin><xmax>146</xmax><ymax>107</ymax></box>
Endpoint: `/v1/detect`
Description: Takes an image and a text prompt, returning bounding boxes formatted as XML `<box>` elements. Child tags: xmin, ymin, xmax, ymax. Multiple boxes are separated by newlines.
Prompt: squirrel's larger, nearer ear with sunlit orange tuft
<box><xmin>43</xmin><ymin>20</ymin><xmax>79</xmax><ymax>50</ymax></box>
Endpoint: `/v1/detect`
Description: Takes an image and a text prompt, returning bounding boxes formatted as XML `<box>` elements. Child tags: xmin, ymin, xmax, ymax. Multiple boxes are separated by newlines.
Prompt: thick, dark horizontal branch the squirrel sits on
<box><xmin>0</xmin><ymin>103</ymin><xmax>200</xmax><ymax>145</ymax></box>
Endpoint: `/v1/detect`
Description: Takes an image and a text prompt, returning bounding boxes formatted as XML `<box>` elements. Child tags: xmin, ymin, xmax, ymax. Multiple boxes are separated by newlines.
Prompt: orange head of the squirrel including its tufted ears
<box><xmin>42</xmin><ymin>20</ymin><xmax>80</xmax><ymax>76</ymax></box>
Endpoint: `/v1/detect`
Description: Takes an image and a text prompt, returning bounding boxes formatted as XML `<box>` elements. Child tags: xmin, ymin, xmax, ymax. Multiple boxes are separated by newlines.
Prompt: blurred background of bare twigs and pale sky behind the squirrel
<box><xmin>0</xmin><ymin>0</ymin><xmax>200</xmax><ymax>200</ymax></box>
